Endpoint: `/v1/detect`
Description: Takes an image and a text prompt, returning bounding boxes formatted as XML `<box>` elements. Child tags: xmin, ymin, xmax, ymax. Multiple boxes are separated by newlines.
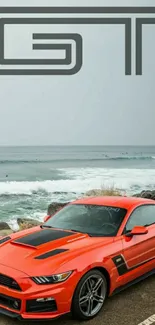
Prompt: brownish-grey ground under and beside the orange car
<box><xmin>0</xmin><ymin>276</ymin><xmax>155</xmax><ymax>325</ymax></box>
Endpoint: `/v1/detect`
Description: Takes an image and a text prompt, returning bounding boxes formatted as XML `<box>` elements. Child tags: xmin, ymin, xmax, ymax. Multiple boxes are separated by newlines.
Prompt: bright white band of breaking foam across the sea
<box><xmin>0</xmin><ymin>168</ymin><xmax>155</xmax><ymax>195</ymax></box>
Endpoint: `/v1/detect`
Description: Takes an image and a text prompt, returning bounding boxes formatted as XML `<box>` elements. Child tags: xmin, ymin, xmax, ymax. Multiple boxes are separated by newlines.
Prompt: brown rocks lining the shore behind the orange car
<box><xmin>0</xmin><ymin>190</ymin><xmax>155</xmax><ymax>237</ymax></box>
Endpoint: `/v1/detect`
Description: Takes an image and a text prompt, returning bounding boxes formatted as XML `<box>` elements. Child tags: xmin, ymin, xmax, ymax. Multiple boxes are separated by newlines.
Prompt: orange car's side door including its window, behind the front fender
<box><xmin>122</xmin><ymin>204</ymin><xmax>155</xmax><ymax>282</ymax></box>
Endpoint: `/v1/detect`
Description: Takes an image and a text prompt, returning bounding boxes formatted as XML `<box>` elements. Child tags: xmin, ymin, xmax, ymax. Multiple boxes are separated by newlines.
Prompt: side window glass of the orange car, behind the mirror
<box><xmin>123</xmin><ymin>205</ymin><xmax>155</xmax><ymax>233</ymax></box>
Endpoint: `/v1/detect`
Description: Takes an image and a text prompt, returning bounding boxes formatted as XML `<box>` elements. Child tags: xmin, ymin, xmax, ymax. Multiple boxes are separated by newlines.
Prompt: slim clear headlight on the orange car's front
<box><xmin>31</xmin><ymin>271</ymin><xmax>72</xmax><ymax>284</ymax></box>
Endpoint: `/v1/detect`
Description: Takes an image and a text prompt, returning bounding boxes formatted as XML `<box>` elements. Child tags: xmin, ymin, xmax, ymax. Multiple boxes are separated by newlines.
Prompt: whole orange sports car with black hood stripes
<box><xmin>0</xmin><ymin>197</ymin><xmax>155</xmax><ymax>320</ymax></box>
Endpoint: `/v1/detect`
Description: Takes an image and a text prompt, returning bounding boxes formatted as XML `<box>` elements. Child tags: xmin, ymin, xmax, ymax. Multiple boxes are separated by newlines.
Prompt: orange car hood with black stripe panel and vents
<box><xmin>0</xmin><ymin>227</ymin><xmax>113</xmax><ymax>276</ymax></box>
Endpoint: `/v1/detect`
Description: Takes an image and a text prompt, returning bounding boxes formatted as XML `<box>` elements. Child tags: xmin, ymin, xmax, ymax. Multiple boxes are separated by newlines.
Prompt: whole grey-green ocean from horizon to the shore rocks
<box><xmin>0</xmin><ymin>146</ymin><xmax>155</xmax><ymax>228</ymax></box>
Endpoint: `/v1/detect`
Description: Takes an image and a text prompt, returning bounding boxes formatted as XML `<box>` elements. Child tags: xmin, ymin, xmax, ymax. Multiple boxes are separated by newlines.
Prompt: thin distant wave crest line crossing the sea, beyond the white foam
<box><xmin>0</xmin><ymin>155</ymin><xmax>155</xmax><ymax>165</ymax></box>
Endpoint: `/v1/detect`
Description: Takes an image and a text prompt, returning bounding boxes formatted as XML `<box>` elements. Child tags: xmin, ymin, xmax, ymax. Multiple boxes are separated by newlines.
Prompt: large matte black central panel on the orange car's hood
<box><xmin>14</xmin><ymin>229</ymin><xmax>73</xmax><ymax>247</ymax></box>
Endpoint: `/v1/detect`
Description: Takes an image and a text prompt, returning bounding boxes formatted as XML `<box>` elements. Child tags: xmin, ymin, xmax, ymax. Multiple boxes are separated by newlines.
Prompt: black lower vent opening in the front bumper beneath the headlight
<box><xmin>26</xmin><ymin>299</ymin><xmax>57</xmax><ymax>313</ymax></box>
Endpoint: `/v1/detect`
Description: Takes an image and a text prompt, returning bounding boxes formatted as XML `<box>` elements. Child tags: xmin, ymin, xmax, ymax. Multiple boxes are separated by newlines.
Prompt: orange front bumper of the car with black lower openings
<box><xmin>0</xmin><ymin>265</ymin><xmax>75</xmax><ymax>320</ymax></box>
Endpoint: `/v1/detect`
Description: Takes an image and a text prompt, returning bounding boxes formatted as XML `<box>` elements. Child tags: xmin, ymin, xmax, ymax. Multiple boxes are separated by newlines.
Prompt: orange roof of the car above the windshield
<box><xmin>71</xmin><ymin>196</ymin><xmax>155</xmax><ymax>209</ymax></box>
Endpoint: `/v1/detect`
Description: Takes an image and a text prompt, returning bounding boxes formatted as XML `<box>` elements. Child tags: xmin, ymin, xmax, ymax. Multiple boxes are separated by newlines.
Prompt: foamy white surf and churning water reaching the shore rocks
<box><xmin>0</xmin><ymin>168</ymin><xmax>155</xmax><ymax>225</ymax></box>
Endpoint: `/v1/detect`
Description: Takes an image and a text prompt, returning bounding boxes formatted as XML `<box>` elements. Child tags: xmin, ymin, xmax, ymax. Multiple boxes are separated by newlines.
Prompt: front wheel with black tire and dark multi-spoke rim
<box><xmin>71</xmin><ymin>269</ymin><xmax>107</xmax><ymax>321</ymax></box>
